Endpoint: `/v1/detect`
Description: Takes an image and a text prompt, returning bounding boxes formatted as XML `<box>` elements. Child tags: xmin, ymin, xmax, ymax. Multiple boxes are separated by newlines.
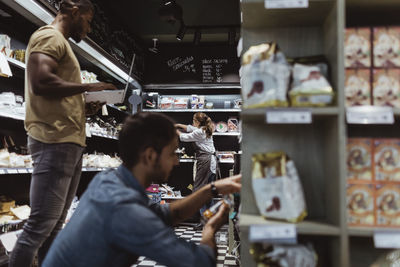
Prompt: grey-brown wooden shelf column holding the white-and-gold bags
<box><xmin>240</xmin><ymin>0</ymin><xmax>350</xmax><ymax>267</ymax></box>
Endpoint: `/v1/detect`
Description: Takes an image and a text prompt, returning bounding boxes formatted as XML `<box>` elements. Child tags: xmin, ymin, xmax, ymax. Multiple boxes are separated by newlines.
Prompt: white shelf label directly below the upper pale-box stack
<box><xmin>346</xmin><ymin>106</ymin><xmax>394</xmax><ymax>124</ymax></box>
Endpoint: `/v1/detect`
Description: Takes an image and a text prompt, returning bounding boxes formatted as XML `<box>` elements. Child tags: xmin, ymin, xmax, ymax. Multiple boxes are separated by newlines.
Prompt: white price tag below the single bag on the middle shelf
<box><xmin>249</xmin><ymin>224</ymin><xmax>297</xmax><ymax>244</ymax></box>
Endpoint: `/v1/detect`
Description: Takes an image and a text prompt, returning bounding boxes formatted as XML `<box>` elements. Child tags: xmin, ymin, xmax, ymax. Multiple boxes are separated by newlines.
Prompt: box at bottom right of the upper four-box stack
<box><xmin>372</xmin><ymin>69</ymin><xmax>400</xmax><ymax>107</ymax></box>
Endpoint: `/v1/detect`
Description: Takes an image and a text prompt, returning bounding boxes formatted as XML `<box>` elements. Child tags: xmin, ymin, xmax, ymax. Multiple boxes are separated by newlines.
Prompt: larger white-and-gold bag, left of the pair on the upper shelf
<box><xmin>241</xmin><ymin>43</ymin><xmax>290</xmax><ymax>109</ymax></box>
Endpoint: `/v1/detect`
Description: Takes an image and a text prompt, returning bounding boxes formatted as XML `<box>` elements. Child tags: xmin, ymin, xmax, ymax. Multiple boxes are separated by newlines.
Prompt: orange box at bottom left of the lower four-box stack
<box><xmin>346</xmin><ymin>184</ymin><xmax>375</xmax><ymax>226</ymax></box>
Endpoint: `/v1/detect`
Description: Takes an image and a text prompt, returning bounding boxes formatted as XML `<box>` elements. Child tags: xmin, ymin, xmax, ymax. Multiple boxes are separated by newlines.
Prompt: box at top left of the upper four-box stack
<box><xmin>344</xmin><ymin>28</ymin><xmax>371</xmax><ymax>68</ymax></box>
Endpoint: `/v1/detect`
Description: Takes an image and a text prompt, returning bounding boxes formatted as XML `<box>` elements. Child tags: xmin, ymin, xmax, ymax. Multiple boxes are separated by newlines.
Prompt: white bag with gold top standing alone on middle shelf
<box><xmin>252</xmin><ymin>152</ymin><xmax>307</xmax><ymax>222</ymax></box>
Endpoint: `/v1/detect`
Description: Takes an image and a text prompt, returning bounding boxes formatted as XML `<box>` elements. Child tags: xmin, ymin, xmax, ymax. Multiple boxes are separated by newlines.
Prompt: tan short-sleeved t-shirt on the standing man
<box><xmin>25</xmin><ymin>25</ymin><xmax>86</xmax><ymax>146</ymax></box>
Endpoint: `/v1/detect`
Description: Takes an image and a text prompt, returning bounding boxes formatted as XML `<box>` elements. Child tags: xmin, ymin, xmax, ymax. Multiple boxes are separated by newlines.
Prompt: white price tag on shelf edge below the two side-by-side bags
<box><xmin>266</xmin><ymin>109</ymin><xmax>312</xmax><ymax>124</ymax></box>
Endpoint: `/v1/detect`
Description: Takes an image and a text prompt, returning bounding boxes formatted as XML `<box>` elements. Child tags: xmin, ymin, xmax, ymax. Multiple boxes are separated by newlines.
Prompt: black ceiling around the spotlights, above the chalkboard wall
<box><xmin>97</xmin><ymin>0</ymin><xmax>240</xmax><ymax>43</ymax></box>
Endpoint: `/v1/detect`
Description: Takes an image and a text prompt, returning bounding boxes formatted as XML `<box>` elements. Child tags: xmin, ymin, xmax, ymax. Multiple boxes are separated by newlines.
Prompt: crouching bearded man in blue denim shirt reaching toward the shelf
<box><xmin>43</xmin><ymin>113</ymin><xmax>241</xmax><ymax>267</ymax></box>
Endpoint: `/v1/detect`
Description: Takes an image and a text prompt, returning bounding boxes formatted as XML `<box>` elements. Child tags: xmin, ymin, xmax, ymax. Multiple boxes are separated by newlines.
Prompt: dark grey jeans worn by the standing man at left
<box><xmin>9</xmin><ymin>137</ymin><xmax>84</xmax><ymax>267</ymax></box>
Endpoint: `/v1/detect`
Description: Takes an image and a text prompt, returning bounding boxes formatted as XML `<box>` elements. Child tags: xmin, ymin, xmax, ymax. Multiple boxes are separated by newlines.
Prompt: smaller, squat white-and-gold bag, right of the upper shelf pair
<box><xmin>289</xmin><ymin>63</ymin><xmax>334</xmax><ymax>107</ymax></box>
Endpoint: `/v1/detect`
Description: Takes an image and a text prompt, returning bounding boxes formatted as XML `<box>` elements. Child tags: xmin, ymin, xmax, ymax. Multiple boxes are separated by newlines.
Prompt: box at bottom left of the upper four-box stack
<box><xmin>344</xmin><ymin>69</ymin><xmax>372</xmax><ymax>107</ymax></box>
